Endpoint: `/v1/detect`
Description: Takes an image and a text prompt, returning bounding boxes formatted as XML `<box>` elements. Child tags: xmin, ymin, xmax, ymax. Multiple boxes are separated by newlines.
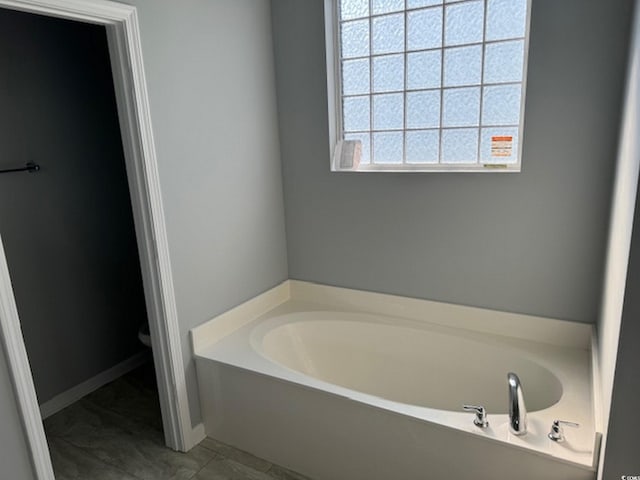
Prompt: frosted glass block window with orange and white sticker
<box><xmin>333</xmin><ymin>0</ymin><xmax>530</xmax><ymax>170</ymax></box>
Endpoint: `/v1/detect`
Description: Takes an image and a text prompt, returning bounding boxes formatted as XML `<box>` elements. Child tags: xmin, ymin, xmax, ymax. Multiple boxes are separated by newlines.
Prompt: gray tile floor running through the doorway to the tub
<box><xmin>44</xmin><ymin>364</ymin><xmax>306</xmax><ymax>480</ymax></box>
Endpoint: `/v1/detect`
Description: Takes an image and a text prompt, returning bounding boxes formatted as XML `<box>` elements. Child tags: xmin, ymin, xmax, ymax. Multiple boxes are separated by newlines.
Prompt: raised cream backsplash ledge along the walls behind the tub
<box><xmin>191</xmin><ymin>280</ymin><xmax>593</xmax><ymax>352</ymax></box>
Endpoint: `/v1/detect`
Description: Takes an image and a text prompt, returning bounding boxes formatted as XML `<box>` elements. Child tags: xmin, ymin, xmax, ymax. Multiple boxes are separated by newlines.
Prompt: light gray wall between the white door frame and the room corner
<box><xmin>122</xmin><ymin>0</ymin><xmax>287</xmax><ymax>423</ymax></box>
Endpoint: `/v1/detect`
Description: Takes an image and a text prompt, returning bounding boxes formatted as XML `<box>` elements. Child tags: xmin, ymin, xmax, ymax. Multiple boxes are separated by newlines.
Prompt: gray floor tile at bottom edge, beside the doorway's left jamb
<box><xmin>49</xmin><ymin>438</ymin><xmax>138</xmax><ymax>480</ymax></box>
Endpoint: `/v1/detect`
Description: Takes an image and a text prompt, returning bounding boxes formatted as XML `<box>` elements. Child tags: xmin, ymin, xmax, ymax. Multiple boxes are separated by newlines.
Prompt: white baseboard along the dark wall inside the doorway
<box><xmin>40</xmin><ymin>351</ymin><xmax>149</xmax><ymax>420</ymax></box>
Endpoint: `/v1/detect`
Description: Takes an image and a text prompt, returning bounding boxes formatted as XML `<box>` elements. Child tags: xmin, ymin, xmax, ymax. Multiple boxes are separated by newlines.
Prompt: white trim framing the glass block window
<box><xmin>324</xmin><ymin>0</ymin><xmax>532</xmax><ymax>173</ymax></box>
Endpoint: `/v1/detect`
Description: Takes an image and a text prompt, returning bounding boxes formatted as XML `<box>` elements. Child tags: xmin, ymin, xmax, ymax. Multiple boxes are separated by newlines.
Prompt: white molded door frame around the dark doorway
<box><xmin>0</xmin><ymin>0</ymin><xmax>194</xmax><ymax>480</ymax></box>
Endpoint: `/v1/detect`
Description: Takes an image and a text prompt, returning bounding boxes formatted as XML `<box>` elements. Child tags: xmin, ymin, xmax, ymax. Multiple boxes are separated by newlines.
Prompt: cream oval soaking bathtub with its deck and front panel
<box><xmin>192</xmin><ymin>284</ymin><xmax>599</xmax><ymax>480</ymax></box>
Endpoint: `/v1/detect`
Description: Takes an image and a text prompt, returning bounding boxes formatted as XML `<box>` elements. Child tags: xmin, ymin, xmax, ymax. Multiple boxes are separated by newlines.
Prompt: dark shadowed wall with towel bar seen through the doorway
<box><xmin>0</xmin><ymin>10</ymin><xmax>146</xmax><ymax>403</ymax></box>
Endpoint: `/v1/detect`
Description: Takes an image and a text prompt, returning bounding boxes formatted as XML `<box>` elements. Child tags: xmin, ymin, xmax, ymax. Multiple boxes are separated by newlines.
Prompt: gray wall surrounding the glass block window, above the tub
<box><xmin>272</xmin><ymin>0</ymin><xmax>632</xmax><ymax>322</ymax></box>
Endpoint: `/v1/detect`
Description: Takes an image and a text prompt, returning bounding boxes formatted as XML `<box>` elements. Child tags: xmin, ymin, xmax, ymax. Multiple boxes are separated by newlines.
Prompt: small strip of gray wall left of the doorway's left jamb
<box><xmin>0</xmin><ymin>342</ymin><xmax>34</xmax><ymax>480</ymax></box>
